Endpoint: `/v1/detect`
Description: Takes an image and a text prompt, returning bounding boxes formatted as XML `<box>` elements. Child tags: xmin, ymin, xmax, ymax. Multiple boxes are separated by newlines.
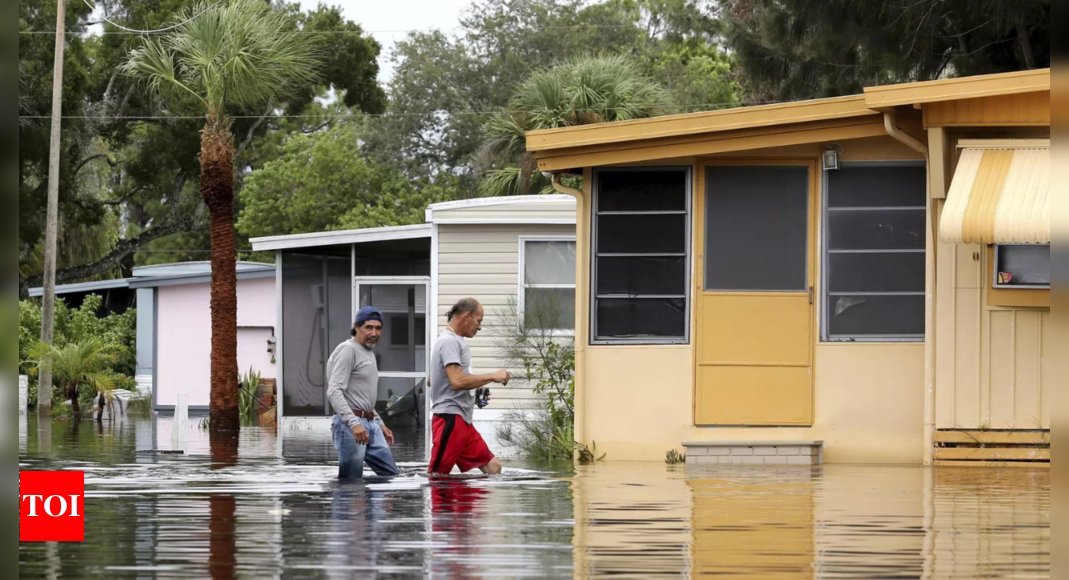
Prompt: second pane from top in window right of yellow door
<box><xmin>827</xmin><ymin>209</ymin><xmax>925</xmax><ymax>250</ymax></box>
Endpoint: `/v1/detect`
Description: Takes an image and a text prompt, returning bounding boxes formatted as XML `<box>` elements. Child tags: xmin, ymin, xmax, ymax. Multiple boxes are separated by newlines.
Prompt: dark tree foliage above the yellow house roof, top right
<box><xmin>721</xmin><ymin>0</ymin><xmax>1051</xmax><ymax>100</ymax></box>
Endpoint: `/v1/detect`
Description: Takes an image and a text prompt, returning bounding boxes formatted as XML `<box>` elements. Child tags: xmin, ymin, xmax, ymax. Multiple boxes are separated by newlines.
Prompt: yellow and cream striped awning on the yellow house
<box><xmin>940</xmin><ymin>139</ymin><xmax>1051</xmax><ymax>244</ymax></box>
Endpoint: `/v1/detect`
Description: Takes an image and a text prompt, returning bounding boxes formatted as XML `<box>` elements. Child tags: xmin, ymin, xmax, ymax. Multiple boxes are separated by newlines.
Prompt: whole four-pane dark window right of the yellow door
<box><xmin>823</xmin><ymin>163</ymin><xmax>927</xmax><ymax>341</ymax></box>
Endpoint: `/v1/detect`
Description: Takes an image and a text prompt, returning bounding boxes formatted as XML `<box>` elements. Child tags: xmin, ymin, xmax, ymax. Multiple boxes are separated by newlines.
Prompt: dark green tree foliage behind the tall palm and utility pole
<box><xmin>18</xmin><ymin>0</ymin><xmax>385</xmax><ymax>296</ymax></box>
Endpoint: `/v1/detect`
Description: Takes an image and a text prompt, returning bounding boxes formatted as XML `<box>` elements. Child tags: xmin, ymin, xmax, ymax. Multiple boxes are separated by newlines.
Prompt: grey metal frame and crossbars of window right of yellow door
<box><xmin>819</xmin><ymin>159</ymin><xmax>928</xmax><ymax>344</ymax></box>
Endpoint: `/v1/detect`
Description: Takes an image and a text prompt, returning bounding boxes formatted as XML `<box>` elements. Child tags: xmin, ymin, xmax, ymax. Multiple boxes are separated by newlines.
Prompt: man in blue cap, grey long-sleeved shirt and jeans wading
<box><xmin>327</xmin><ymin>307</ymin><xmax>400</xmax><ymax>480</ymax></box>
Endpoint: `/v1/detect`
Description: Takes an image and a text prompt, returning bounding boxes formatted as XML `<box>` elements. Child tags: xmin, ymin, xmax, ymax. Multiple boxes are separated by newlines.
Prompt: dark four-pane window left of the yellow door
<box><xmin>592</xmin><ymin>169</ymin><xmax>691</xmax><ymax>344</ymax></box>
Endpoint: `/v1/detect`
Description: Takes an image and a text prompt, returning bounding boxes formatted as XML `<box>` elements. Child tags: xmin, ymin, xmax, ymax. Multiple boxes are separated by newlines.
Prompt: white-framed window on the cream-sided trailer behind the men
<box><xmin>521</xmin><ymin>238</ymin><xmax>575</xmax><ymax>331</ymax></box>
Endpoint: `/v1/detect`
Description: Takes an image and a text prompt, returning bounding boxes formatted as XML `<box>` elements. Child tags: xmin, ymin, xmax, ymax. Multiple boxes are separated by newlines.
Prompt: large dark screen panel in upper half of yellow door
<box><xmin>706</xmin><ymin>167</ymin><xmax>809</xmax><ymax>291</ymax></box>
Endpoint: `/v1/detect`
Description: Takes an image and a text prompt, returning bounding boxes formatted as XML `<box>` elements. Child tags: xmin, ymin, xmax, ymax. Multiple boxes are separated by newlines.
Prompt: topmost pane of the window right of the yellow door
<box><xmin>827</xmin><ymin>166</ymin><xmax>928</xmax><ymax>207</ymax></box>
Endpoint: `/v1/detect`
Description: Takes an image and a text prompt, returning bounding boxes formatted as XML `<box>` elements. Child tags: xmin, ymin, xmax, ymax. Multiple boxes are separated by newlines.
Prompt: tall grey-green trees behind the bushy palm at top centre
<box><xmin>366</xmin><ymin>0</ymin><xmax>737</xmax><ymax>185</ymax></box>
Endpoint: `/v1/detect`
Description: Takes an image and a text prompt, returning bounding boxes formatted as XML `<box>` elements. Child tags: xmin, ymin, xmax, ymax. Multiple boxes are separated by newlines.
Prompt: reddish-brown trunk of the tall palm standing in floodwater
<box><xmin>201</xmin><ymin>117</ymin><xmax>241</xmax><ymax>432</ymax></box>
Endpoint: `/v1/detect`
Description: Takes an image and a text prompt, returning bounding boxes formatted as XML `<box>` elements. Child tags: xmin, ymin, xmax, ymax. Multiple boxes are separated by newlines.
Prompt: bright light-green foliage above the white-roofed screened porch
<box><xmin>237</xmin><ymin>123</ymin><xmax>459</xmax><ymax>237</ymax></box>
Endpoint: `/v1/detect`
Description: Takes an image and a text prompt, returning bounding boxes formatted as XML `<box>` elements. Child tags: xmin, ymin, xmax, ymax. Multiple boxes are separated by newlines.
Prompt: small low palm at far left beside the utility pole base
<box><xmin>26</xmin><ymin>339</ymin><xmax>115</xmax><ymax>421</ymax></box>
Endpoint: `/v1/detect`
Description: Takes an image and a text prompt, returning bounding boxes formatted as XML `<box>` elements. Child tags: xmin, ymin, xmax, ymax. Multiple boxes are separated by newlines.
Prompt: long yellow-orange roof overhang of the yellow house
<box><xmin>527</xmin><ymin>68</ymin><xmax>1051</xmax><ymax>172</ymax></box>
